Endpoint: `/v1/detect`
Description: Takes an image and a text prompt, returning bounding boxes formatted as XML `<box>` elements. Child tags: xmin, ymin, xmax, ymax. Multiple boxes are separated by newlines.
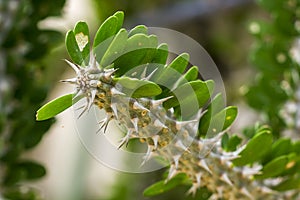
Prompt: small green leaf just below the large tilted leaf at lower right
<box><xmin>255</xmin><ymin>156</ymin><xmax>289</xmax><ymax>179</ymax></box>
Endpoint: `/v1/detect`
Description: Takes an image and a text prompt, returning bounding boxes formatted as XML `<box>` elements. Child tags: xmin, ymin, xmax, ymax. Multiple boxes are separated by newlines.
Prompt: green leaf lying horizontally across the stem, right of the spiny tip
<box><xmin>114</xmin><ymin>76</ymin><xmax>161</xmax><ymax>98</ymax></box>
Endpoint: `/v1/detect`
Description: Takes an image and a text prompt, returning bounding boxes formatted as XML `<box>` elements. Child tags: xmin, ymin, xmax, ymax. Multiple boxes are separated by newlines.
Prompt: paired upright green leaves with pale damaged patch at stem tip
<box><xmin>66</xmin><ymin>22</ymin><xmax>90</xmax><ymax>66</ymax></box>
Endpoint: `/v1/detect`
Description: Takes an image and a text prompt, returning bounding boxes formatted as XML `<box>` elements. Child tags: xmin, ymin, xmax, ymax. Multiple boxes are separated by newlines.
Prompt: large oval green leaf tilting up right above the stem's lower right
<box><xmin>233</xmin><ymin>130</ymin><xmax>273</xmax><ymax>166</ymax></box>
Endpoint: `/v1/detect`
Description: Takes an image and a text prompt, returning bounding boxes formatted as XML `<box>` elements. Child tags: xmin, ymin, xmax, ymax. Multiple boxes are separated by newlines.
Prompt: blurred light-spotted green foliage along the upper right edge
<box><xmin>244</xmin><ymin>0</ymin><xmax>300</xmax><ymax>137</ymax></box>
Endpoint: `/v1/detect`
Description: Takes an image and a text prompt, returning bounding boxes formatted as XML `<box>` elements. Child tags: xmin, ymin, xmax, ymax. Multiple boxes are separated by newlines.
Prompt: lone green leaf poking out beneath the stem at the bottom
<box><xmin>144</xmin><ymin>173</ymin><xmax>187</xmax><ymax>197</ymax></box>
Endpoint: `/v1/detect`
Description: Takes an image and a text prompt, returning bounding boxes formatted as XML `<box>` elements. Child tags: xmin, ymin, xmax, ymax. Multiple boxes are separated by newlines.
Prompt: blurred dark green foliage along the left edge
<box><xmin>0</xmin><ymin>0</ymin><xmax>65</xmax><ymax>200</ymax></box>
